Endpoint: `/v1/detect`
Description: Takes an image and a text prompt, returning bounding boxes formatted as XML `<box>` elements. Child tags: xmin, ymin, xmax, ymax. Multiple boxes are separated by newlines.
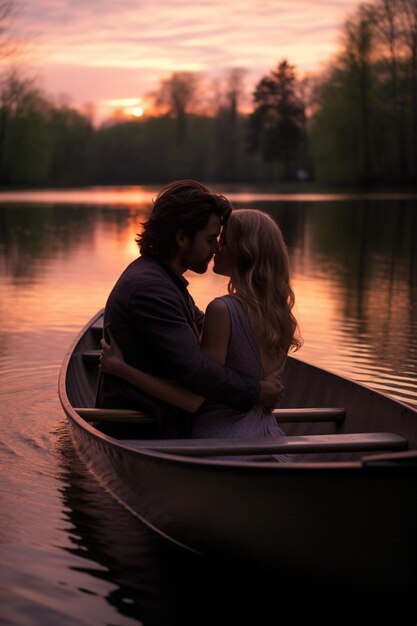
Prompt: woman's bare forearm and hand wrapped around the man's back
<box><xmin>100</xmin><ymin>337</ymin><xmax>204</xmax><ymax>413</ymax></box>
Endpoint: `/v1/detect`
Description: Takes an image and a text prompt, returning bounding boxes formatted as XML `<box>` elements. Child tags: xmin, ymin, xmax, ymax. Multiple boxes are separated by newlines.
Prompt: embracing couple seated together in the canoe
<box><xmin>97</xmin><ymin>181</ymin><xmax>301</xmax><ymax>450</ymax></box>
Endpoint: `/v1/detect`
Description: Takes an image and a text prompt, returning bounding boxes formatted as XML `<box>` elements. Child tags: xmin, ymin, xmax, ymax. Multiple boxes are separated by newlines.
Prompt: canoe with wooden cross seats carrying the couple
<box><xmin>59</xmin><ymin>311</ymin><xmax>417</xmax><ymax>623</ymax></box>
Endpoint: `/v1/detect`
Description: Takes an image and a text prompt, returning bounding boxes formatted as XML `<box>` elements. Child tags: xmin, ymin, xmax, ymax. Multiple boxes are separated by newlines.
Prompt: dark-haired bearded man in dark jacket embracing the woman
<box><xmin>97</xmin><ymin>181</ymin><xmax>280</xmax><ymax>436</ymax></box>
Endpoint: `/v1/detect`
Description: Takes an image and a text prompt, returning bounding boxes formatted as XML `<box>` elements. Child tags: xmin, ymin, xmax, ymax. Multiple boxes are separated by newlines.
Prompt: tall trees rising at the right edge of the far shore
<box><xmin>309</xmin><ymin>0</ymin><xmax>417</xmax><ymax>184</ymax></box>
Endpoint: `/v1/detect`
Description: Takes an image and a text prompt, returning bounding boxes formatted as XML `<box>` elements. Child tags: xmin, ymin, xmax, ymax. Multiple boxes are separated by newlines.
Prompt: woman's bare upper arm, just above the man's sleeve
<box><xmin>201</xmin><ymin>298</ymin><xmax>231</xmax><ymax>365</ymax></box>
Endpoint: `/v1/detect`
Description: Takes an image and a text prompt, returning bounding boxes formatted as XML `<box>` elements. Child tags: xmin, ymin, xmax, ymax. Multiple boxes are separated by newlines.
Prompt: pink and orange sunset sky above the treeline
<box><xmin>11</xmin><ymin>0</ymin><xmax>359</xmax><ymax>121</ymax></box>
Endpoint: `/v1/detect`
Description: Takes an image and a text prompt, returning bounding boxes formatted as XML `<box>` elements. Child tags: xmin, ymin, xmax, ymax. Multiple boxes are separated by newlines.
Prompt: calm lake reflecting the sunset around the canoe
<box><xmin>0</xmin><ymin>187</ymin><xmax>417</xmax><ymax>626</ymax></box>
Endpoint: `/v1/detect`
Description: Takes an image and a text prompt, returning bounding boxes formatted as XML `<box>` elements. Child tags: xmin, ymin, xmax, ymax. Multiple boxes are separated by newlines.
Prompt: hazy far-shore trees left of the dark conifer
<box><xmin>0</xmin><ymin>74</ymin><xmax>286</xmax><ymax>186</ymax></box>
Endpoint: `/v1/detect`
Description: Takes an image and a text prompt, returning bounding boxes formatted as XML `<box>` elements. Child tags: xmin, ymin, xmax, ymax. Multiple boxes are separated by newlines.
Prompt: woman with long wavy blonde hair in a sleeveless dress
<box><xmin>102</xmin><ymin>209</ymin><xmax>302</xmax><ymax>460</ymax></box>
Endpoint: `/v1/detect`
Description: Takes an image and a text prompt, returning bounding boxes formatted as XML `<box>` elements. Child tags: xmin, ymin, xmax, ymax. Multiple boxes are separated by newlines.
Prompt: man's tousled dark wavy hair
<box><xmin>136</xmin><ymin>180</ymin><xmax>232</xmax><ymax>261</ymax></box>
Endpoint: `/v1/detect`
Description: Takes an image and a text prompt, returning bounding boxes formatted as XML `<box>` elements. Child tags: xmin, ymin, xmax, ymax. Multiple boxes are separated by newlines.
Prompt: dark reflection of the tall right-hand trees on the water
<box><xmin>302</xmin><ymin>202</ymin><xmax>417</xmax><ymax>402</ymax></box>
